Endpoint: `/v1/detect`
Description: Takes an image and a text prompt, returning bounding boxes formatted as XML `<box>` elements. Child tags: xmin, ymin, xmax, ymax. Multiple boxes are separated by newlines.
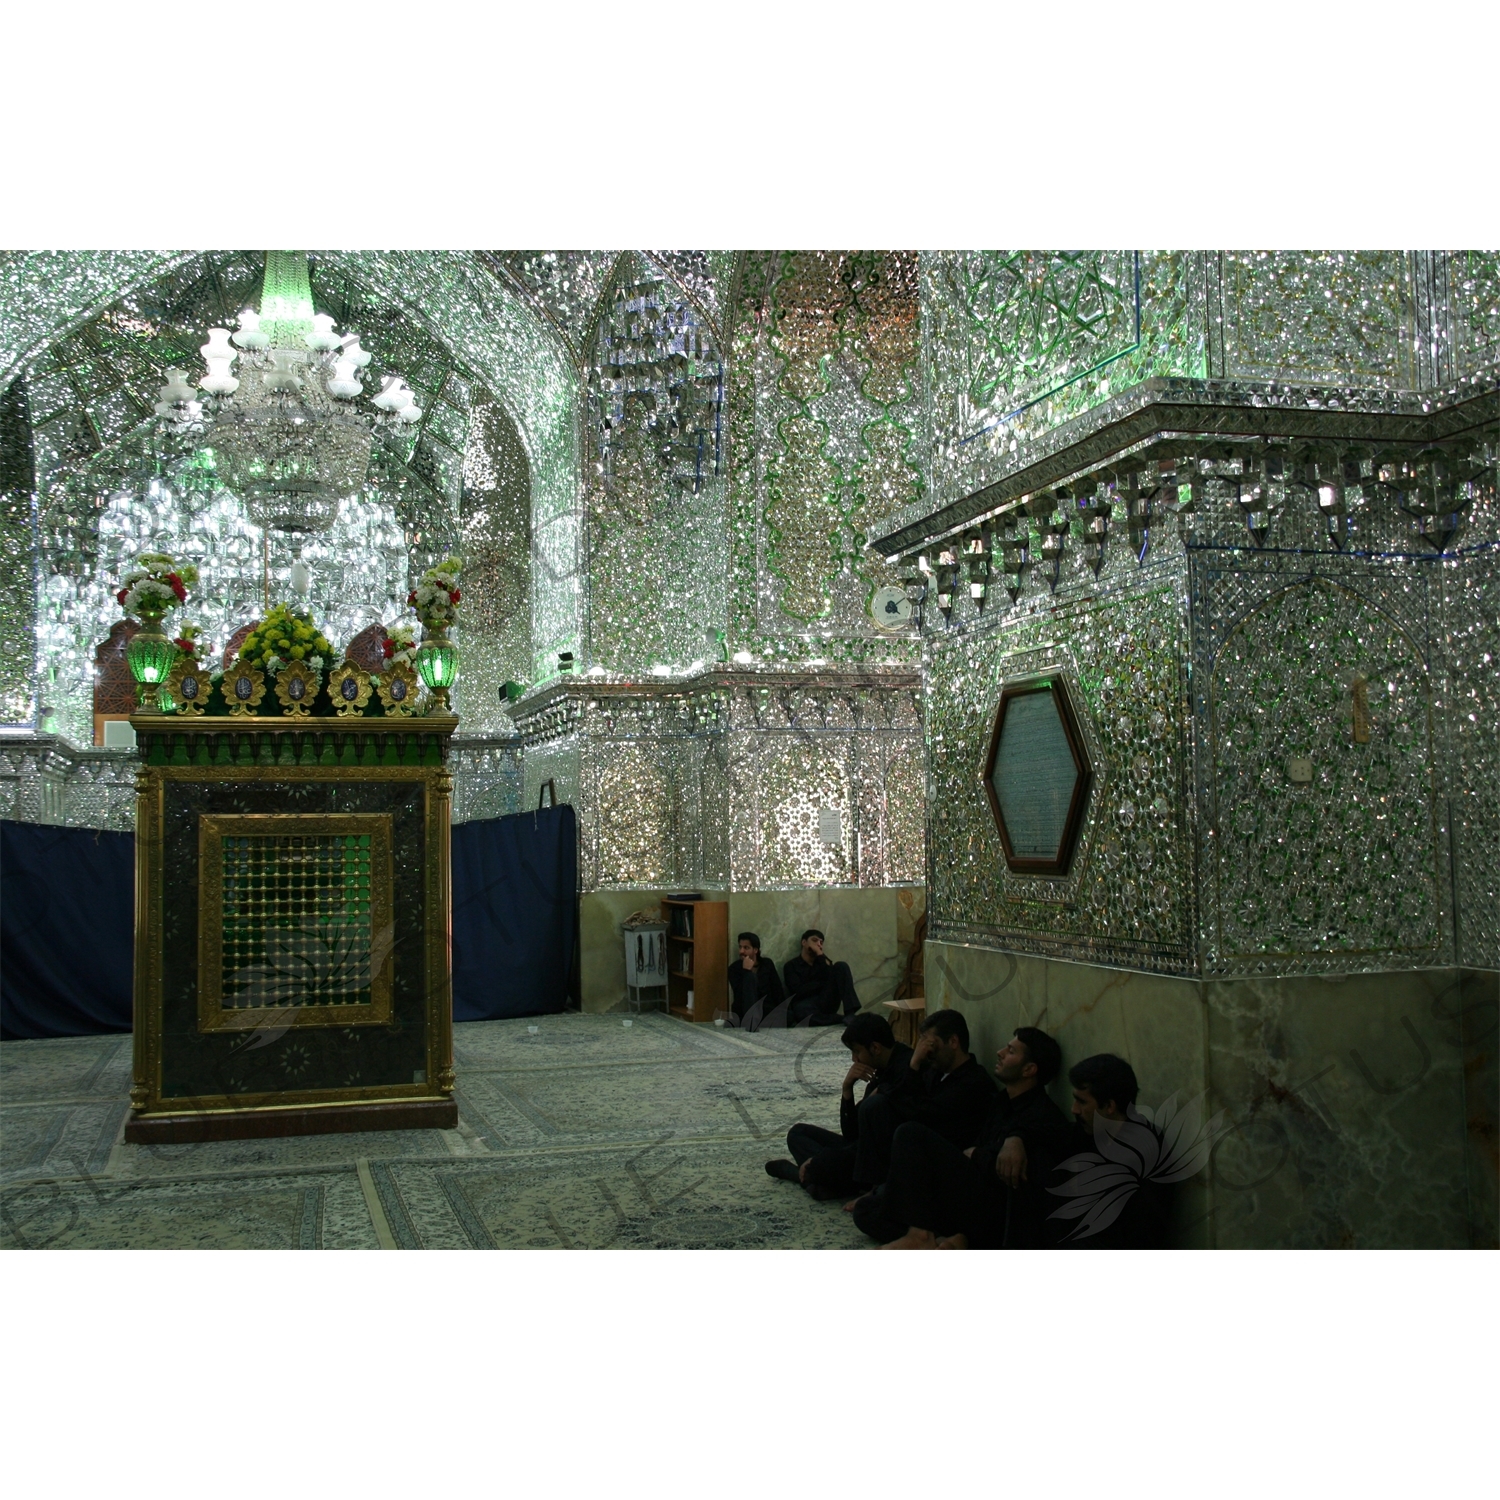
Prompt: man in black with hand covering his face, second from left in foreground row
<box><xmin>846</xmin><ymin>1010</ymin><xmax>998</xmax><ymax>1239</ymax></box>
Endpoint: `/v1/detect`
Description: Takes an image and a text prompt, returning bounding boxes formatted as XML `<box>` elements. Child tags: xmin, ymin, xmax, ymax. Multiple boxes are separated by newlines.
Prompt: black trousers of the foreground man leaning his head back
<box><xmin>855</xmin><ymin>1122</ymin><xmax>1010</xmax><ymax>1250</ymax></box>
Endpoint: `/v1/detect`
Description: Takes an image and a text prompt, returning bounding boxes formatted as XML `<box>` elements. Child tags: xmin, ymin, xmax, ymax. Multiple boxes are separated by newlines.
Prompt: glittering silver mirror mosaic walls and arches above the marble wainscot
<box><xmin>0</xmin><ymin>251</ymin><xmax>1500</xmax><ymax>924</ymax></box>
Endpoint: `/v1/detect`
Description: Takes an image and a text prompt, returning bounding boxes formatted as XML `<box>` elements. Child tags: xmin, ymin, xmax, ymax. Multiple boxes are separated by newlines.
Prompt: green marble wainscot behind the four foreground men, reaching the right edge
<box><xmin>927</xmin><ymin>942</ymin><xmax>1496</xmax><ymax>1250</ymax></box>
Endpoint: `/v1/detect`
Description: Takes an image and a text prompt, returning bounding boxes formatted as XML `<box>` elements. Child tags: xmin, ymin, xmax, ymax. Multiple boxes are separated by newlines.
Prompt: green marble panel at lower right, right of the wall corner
<box><xmin>1205</xmin><ymin>969</ymin><xmax>1472</xmax><ymax>1250</ymax></box>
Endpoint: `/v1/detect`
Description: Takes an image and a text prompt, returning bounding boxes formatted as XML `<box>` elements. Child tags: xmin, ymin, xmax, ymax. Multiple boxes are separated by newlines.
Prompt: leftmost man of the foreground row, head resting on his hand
<box><xmin>765</xmin><ymin>1016</ymin><xmax>912</xmax><ymax>1199</ymax></box>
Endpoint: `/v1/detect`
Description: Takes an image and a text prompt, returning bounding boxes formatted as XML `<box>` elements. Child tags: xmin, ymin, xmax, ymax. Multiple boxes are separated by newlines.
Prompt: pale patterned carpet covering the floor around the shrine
<box><xmin>0</xmin><ymin>1016</ymin><xmax>869</xmax><ymax>1250</ymax></box>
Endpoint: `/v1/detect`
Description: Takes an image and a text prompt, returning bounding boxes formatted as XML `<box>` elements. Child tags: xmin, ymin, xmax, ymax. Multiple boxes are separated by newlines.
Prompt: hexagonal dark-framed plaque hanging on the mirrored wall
<box><xmin>984</xmin><ymin>674</ymin><xmax>1094</xmax><ymax>875</ymax></box>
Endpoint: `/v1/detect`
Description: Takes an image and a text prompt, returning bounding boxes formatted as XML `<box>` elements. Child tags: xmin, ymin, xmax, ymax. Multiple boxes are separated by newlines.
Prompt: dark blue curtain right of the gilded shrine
<box><xmin>453</xmin><ymin>803</ymin><xmax>578</xmax><ymax>1022</ymax></box>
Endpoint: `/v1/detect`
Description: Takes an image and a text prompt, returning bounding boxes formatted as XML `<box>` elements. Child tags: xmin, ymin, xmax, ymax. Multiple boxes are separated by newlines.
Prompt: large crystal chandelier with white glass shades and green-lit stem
<box><xmin>156</xmin><ymin>251</ymin><xmax>422</xmax><ymax>567</ymax></box>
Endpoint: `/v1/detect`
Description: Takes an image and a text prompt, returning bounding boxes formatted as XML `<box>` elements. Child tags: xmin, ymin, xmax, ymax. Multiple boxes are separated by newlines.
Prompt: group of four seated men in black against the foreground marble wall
<box><xmin>765</xmin><ymin>1010</ymin><xmax>1169</xmax><ymax>1250</ymax></box>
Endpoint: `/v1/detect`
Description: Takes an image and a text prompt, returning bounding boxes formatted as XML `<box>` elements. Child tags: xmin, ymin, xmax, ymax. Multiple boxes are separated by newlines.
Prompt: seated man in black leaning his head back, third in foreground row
<box><xmin>855</xmin><ymin>1013</ymin><xmax>1077</xmax><ymax>1250</ymax></box>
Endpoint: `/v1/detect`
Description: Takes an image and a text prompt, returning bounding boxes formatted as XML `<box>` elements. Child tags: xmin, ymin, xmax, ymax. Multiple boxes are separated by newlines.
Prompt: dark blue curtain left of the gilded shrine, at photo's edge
<box><xmin>0</xmin><ymin>822</ymin><xmax>135</xmax><ymax>1041</ymax></box>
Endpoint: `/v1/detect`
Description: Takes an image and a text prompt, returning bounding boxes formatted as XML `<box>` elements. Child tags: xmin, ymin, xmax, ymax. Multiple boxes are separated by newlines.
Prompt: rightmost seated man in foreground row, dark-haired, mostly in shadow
<box><xmin>1049</xmin><ymin>1052</ymin><xmax>1173</xmax><ymax>1250</ymax></box>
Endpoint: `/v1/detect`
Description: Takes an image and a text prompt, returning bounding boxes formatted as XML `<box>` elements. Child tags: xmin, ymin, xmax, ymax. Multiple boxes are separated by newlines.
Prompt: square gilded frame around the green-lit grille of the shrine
<box><xmin>198</xmin><ymin>813</ymin><xmax>396</xmax><ymax>1032</ymax></box>
